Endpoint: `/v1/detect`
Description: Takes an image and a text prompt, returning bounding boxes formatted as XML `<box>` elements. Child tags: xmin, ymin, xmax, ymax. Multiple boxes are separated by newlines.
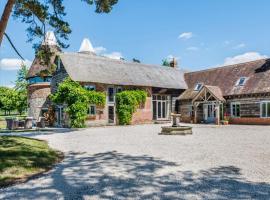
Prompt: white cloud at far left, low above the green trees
<box><xmin>0</xmin><ymin>58</ymin><xmax>32</xmax><ymax>70</ymax></box>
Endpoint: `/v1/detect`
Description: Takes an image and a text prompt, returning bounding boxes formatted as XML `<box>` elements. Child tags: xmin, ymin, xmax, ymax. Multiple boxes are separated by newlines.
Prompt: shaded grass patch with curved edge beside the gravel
<box><xmin>0</xmin><ymin>136</ymin><xmax>63</xmax><ymax>187</ymax></box>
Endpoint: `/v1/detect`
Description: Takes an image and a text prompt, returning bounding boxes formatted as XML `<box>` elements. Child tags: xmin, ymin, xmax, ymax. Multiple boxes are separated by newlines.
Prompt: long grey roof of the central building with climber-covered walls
<box><xmin>59</xmin><ymin>53</ymin><xmax>187</xmax><ymax>89</ymax></box>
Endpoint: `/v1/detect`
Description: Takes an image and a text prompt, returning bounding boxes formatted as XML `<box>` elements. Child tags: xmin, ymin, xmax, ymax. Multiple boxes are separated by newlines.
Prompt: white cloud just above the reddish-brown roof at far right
<box><xmin>223</xmin><ymin>52</ymin><xmax>268</xmax><ymax>65</ymax></box>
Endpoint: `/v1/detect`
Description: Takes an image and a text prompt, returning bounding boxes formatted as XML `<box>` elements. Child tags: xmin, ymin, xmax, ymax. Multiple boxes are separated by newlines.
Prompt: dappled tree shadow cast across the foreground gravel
<box><xmin>0</xmin><ymin>152</ymin><xmax>270</xmax><ymax>199</ymax></box>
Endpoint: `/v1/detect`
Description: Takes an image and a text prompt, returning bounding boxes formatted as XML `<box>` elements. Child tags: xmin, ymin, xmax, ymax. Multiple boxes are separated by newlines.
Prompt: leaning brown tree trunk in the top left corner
<box><xmin>0</xmin><ymin>0</ymin><xmax>16</xmax><ymax>47</ymax></box>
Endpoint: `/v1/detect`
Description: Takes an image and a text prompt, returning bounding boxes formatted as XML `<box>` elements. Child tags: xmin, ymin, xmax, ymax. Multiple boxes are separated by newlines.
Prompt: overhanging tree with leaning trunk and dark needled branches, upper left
<box><xmin>0</xmin><ymin>0</ymin><xmax>118</xmax><ymax>48</ymax></box>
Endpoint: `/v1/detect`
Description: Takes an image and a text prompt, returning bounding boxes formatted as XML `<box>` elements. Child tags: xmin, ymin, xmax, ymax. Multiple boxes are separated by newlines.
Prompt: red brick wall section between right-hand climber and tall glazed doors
<box><xmin>132</xmin><ymin>97</ymin><xmax>153</xmax><ymax>124</ymax></box>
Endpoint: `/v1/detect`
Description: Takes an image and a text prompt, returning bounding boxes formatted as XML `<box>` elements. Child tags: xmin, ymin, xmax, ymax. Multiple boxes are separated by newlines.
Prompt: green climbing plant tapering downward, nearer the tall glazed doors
<box><xmin>116</xmin><ymin>90</ymin><xmax>147</xmax><ymax>125</ymax></box>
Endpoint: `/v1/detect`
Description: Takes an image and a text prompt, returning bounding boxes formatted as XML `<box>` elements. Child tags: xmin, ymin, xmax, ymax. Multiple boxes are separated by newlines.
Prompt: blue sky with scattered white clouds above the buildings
<box><xmin>0</xmin><ymin>0</ymin><xmax>270</xmax><ymax>86</ymax></box>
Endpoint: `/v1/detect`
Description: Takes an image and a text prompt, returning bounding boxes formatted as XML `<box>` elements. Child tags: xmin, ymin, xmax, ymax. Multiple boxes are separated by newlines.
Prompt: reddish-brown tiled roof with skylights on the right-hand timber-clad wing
<box><xmin>184</xmin><ymin>59</ymin><xmax>270</xmax><ymax>99</ymax></box>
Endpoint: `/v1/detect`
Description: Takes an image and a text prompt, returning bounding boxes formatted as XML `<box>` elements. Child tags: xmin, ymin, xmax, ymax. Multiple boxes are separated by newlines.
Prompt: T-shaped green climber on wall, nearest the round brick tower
<box><xmin>50</xmin><ymin>78</ymin><xmax>106</xmax><ymax>128</ymax></box>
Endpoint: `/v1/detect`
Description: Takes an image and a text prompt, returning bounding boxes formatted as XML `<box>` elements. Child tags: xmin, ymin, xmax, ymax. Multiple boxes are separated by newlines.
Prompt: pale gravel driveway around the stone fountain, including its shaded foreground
<box><xmin>0</xmin><ymin>125</ymin><xmax>270</xmax><ymax>200</ymax></box>
